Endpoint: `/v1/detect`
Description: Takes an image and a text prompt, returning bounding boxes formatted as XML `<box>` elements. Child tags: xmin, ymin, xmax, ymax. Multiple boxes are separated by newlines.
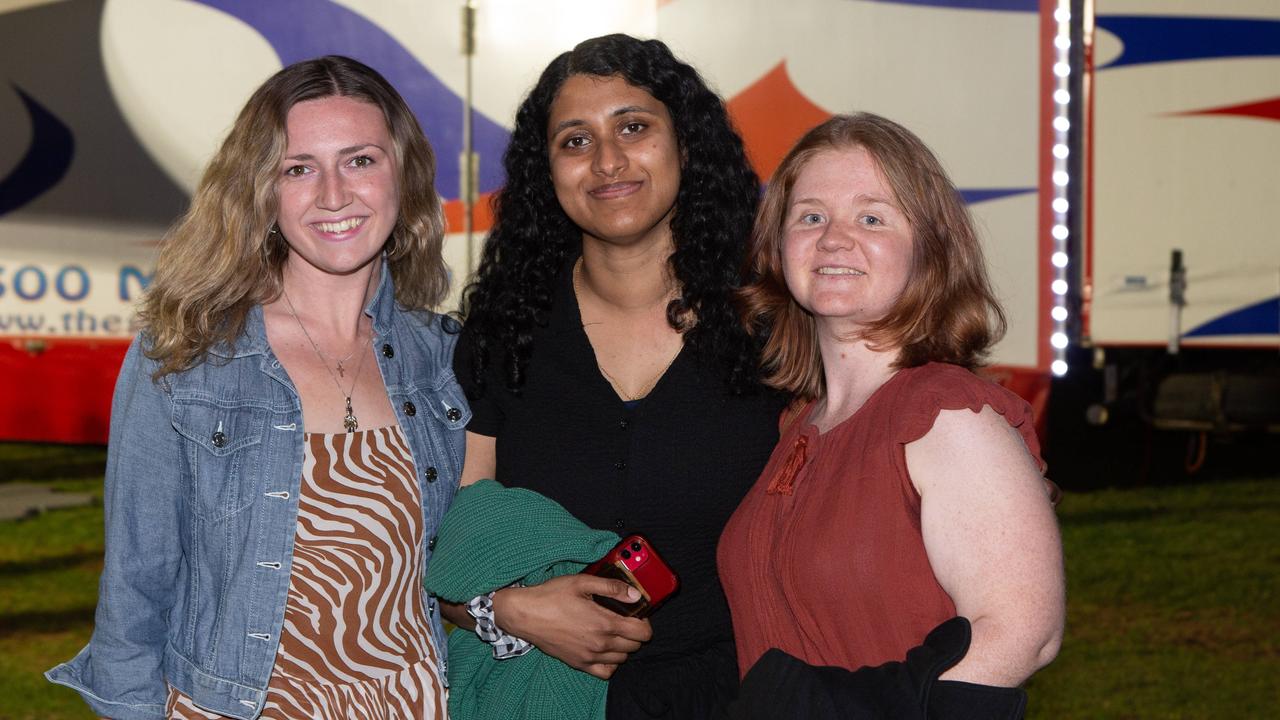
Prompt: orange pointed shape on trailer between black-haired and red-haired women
<box><xmin>728</xmin><ymin>60</ymin><xmax>832</xmax><ymax>181</ymax></box>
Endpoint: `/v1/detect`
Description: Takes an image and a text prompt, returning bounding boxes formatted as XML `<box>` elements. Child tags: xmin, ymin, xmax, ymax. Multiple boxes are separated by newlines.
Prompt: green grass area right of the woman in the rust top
<box><xmin>1028</xmin><ymin>478</ymin><xmax>1280</xmax><ymax>719</ymax></box>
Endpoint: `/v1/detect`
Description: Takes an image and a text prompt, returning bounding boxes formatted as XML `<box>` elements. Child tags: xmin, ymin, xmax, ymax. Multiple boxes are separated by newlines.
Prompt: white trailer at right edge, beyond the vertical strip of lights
<box><xmin>1064</xmin><ymin>0</ymin><xmax>1280</xmax><ymax>477</ymax></box>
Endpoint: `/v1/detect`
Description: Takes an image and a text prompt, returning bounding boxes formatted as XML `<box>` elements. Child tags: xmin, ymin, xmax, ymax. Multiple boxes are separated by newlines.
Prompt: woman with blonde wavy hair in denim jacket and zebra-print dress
<box><xmin>49</xmin><ymin>56</ymin><xmax>470</xmax><ymax>719</ymax></box>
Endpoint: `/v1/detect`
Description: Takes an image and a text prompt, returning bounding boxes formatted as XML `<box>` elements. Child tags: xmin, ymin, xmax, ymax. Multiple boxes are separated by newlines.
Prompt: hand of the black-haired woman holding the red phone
<box><xmin>493</xmin><ymin>574</ymin><xmax>653</xmax><ymax>680</ymax></box>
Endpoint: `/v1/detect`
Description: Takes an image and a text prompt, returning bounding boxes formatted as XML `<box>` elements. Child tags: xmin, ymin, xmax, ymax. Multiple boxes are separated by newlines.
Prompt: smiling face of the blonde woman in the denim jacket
<box><xmin>275</xmin><ymin>96</ymin><xmax>399</xmax><ymax>274</ymax></box>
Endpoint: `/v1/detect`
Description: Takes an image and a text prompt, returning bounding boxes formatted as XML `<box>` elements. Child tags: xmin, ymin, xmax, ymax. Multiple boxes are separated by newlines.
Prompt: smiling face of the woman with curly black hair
<box><xmin>547</xmin><ymin>74</ymin><xmax>680</xmax><ymax>245</ymax></box>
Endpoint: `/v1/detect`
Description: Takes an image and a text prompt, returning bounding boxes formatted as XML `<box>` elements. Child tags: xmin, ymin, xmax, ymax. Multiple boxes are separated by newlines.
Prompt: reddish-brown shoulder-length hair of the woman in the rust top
<box><xmin>737</xmin><ymin>113</ymin><xmax>1006</xmax><ymax>398</ymax></box>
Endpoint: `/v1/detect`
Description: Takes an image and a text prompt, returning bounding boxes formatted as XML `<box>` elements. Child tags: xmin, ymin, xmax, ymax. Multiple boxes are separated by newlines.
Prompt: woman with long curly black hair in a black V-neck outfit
<box><xmin>442</xmin><ymin>35</ymin><xmax>782</xmax><ymax>717</ymax></box>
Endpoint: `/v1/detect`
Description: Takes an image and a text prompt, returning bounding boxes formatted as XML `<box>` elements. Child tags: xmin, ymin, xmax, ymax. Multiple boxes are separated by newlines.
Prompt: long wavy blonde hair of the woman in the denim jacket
<box><xmin>140</xmin><ymin>55</ymin><xmax>448</xmax><ymax>377</ymax></box>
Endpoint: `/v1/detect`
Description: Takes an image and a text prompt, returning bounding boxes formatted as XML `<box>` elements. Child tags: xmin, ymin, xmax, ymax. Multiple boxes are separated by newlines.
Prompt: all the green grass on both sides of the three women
<box><xmin>0</xmin><ymin>445</ymin><xmax>1280</xmax><ymax>720</ymax></box>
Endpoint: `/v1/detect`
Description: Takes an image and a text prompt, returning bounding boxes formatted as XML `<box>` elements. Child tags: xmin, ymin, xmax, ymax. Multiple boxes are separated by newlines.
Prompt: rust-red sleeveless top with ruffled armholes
<box><xmin>717</xmin><ymin>363</ymin><xmax>1043</xmax><ymax>675</ymax></box>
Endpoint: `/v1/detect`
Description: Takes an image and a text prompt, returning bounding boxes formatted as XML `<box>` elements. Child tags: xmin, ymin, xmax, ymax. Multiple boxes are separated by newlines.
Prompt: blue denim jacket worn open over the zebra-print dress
<box><xmin>46</xmin><ymin>273</ymin><xmax>471</xmax><ymax>720</ymax></box>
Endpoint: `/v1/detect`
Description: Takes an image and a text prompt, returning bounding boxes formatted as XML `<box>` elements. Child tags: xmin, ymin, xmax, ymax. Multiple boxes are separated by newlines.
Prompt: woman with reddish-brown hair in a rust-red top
<box><xmin>718</xmin><ymin>113</ymin><xmax>1065</xmax><ymax>717</ymax></box>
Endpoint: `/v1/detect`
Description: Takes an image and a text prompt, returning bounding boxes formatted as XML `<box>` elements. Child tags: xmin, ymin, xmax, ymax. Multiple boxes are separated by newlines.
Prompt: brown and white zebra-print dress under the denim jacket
<box><xmin>166</xmin><ymin>425</ymin><xmax>447</xmax><ymax>720</ymax></box>
